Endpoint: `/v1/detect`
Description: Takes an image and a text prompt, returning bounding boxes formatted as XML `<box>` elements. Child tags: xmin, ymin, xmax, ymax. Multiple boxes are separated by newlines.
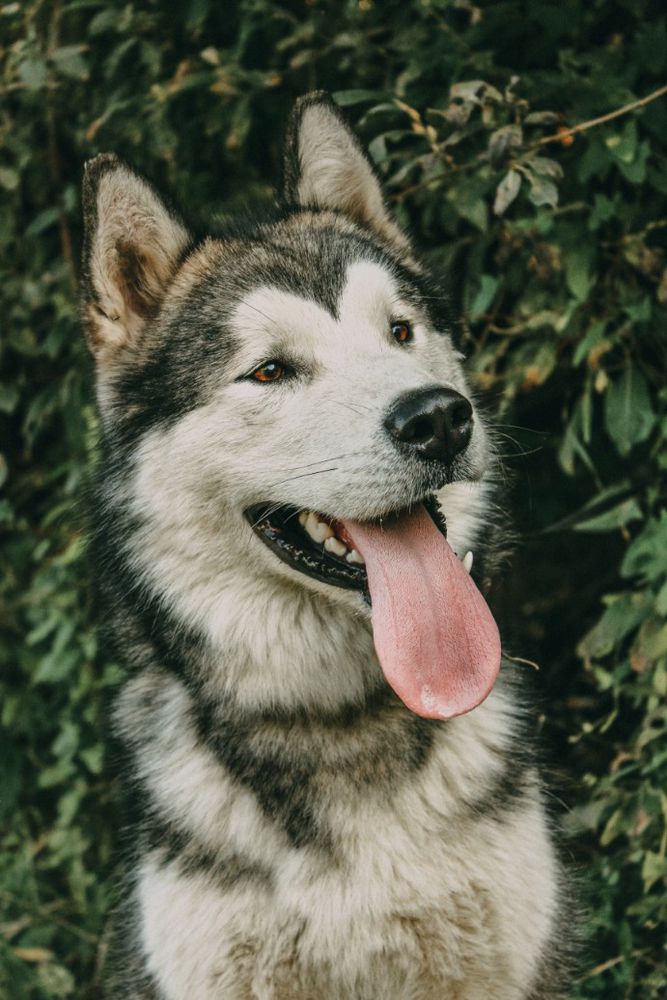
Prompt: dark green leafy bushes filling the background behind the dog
<box><xmin>0</xmin><ymin>0</ymin><xmax>667</xmax><ymax>1000</ymax></box>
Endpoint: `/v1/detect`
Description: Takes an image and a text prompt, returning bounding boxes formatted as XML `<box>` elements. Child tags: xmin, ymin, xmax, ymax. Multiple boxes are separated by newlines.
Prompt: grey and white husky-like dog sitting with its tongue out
<box><xmin>82</xmin><ymin>92</ymin><xmax>569</xmax><ymax>1000</ymax></box>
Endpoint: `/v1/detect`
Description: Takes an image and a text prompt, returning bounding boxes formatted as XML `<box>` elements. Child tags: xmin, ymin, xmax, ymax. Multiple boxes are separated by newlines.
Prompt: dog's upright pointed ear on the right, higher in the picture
<box><xmin>284</xmin><ymin>91</ymin><xmax>410</xmax><ymax>253</ymax></box>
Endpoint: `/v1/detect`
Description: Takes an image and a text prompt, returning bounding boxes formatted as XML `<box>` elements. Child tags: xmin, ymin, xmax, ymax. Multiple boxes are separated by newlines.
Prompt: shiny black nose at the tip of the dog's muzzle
<box><xmin>384</xmin><ymin>389</ymin><xmax>472</xmax><ymax>464</ymax></box>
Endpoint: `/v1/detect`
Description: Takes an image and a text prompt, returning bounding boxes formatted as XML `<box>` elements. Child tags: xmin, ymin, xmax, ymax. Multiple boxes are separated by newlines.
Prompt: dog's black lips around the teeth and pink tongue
<box><xmin>243</xmin><ymin>494</ymin><xmax>447</xmax><ymax>603</ymax></box>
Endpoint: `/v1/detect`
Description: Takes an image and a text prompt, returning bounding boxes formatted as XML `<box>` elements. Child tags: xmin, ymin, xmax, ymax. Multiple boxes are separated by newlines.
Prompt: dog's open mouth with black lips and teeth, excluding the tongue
<box><xmin>244</xmin><ymin>495</ymin><xmax>447</xmax><ymax>597</ymax></box>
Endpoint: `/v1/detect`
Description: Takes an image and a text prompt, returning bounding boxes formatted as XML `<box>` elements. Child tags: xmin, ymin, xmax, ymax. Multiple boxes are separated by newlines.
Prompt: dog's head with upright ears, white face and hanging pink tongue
<box><xmin>84</xmin><ymin>94</ymin><xmax>499</xmax><ymax>717</ymax></box>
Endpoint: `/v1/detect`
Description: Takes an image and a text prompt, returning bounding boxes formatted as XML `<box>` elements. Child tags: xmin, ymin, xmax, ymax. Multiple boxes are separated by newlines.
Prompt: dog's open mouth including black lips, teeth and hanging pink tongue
<box><xmin>245</xmin><ymin>495</ymin><xmax>500</xmax><ymax>719</ymax></box>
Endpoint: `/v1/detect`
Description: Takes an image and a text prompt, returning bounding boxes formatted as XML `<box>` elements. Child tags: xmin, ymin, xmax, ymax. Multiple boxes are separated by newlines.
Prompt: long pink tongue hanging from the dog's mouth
<box><xmin>343</xmin><ymin>506</ymin><xmax>500</xmax><ymax>719</ymax></box>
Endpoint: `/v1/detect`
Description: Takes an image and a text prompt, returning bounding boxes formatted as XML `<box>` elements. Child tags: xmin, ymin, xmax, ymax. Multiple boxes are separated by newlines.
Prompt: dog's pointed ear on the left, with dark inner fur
<box><xmin>83</xmin><ymin>159</ymin><xmax>191</xmax><ymax>364</ymax></box>
